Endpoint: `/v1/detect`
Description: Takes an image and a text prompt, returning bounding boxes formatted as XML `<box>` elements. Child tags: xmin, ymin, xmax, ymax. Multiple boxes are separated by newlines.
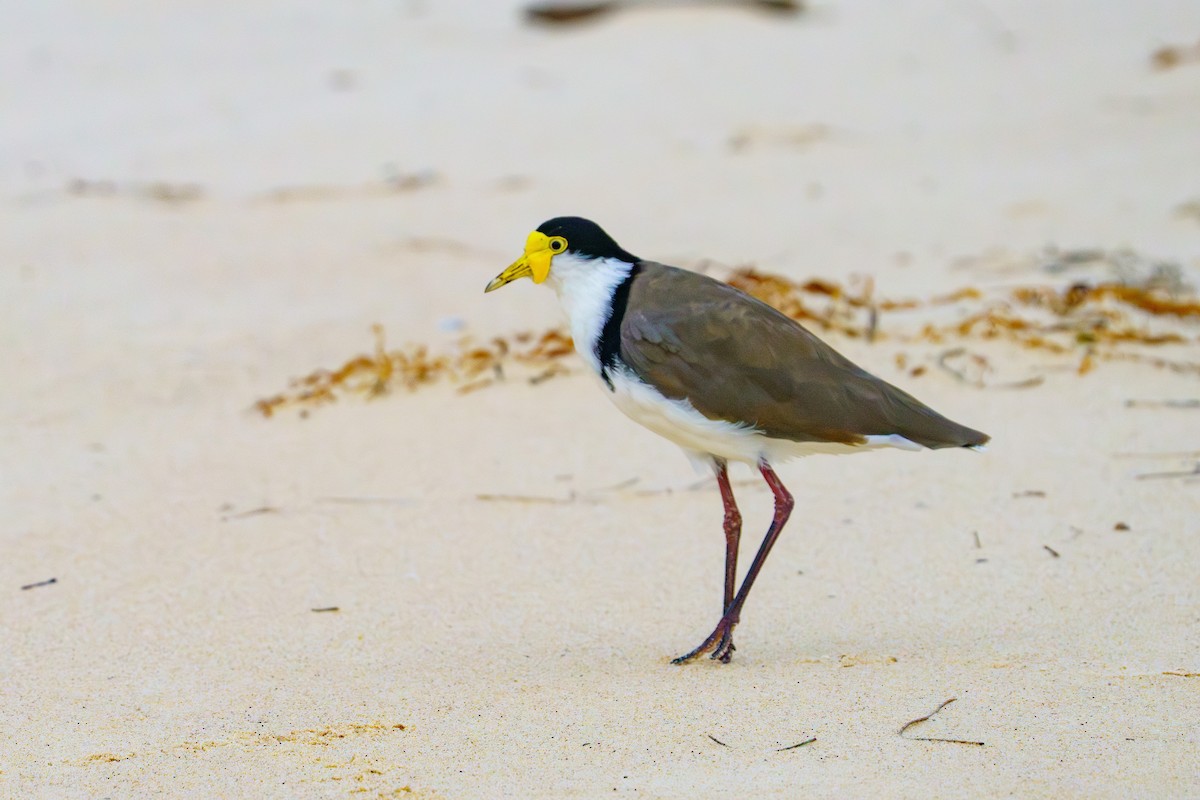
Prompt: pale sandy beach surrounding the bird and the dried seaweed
<box><xmin>0</xmin><ymin>0</ymin><xmax>1200</xmax><ymax>800</ymax></box>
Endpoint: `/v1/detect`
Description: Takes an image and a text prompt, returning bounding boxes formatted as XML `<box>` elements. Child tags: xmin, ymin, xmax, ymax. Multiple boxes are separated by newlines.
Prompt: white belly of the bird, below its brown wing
<box><xmin>605</xmin><ymin>368</ymin><xmax>922</xmax><ymax>465</ymax></box>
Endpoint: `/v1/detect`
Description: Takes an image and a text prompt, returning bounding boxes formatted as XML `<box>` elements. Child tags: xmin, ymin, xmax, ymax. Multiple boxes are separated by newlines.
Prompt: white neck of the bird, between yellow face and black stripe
<box><xmin>546</xmin><ymin>253</ymin><xmax>632</xmax><ymax>373</ymax></box>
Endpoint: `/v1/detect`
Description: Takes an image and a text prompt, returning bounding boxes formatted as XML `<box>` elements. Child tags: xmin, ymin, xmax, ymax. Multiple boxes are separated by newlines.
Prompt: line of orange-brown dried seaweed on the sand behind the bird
<box><xmin>254</xmin><ymin>260</ymin><xmax>1200</xmax><ymax>416</ymax></box>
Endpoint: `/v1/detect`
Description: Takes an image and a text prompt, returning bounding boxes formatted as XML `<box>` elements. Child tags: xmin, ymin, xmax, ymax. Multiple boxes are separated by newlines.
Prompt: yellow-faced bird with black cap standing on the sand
<box><xmin>484</xmin><ymin>217</ymin><xmax>989</xmax><ymax>664</ymax></box>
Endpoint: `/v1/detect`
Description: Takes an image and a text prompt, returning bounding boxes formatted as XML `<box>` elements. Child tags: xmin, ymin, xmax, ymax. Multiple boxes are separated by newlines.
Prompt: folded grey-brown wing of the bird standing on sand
<box><xmin>620</xmin><ymin>261</ymin><xmax>988</xmax><ymax>447</ymax></box>
